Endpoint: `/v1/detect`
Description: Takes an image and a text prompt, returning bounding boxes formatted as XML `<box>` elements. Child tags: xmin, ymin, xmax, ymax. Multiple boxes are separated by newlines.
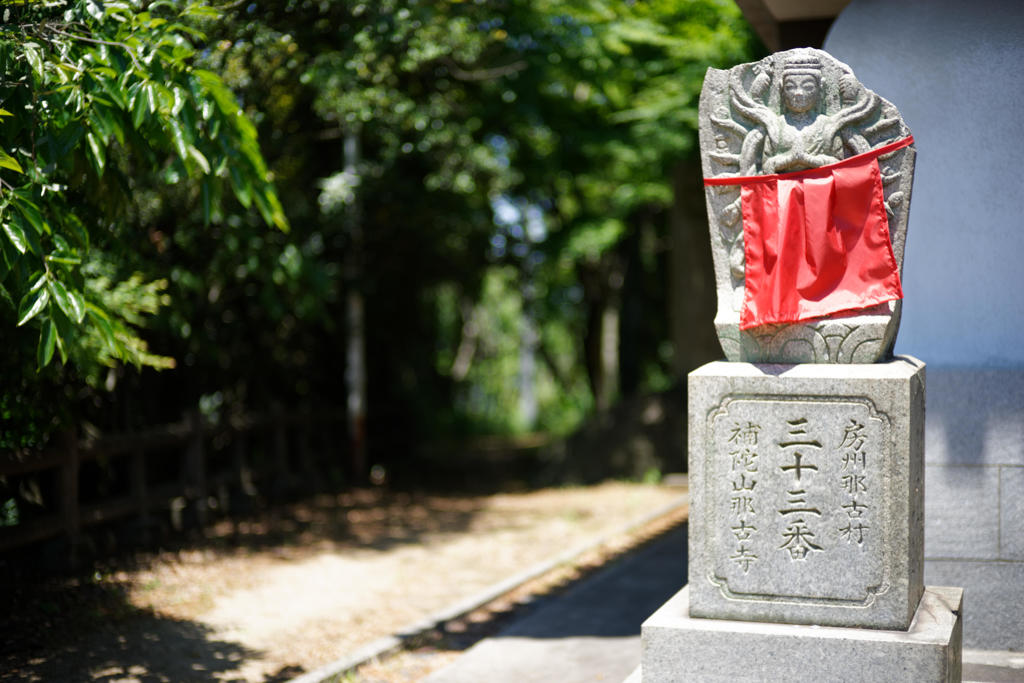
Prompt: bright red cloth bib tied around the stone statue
<box><xmin>705</xmin><ymin>137</ymin><xmax>913</xmax><ymax>330</ymax></box>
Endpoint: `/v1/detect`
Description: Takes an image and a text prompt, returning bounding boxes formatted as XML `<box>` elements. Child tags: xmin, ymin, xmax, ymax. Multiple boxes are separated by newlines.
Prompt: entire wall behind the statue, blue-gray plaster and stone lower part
<box><xmin>824</xmin><ymin>0</ymin><xmax>1024</xmax><ymax>650</ymax></box>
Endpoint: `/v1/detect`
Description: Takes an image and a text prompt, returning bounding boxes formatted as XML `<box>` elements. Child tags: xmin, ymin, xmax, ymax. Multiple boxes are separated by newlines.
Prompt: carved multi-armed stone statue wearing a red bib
<box><xmin>699</xmin><ymin>48</ymin><xmax>915</xmax><ymax>362</ymax></box>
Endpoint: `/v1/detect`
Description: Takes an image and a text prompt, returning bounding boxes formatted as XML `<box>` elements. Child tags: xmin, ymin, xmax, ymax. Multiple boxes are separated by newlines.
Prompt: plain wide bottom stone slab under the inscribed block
<box><xmin>640</xmin><ymin>586</ymin><xmax>964</xmax><ymax>683</ymax></box>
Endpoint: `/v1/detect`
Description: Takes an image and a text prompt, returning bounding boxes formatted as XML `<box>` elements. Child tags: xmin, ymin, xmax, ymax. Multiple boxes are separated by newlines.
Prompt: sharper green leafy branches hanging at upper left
<box><xmin>0</xmin><ymin>0</ymin><xmax>287</xmax><ymax>379</ymax></box>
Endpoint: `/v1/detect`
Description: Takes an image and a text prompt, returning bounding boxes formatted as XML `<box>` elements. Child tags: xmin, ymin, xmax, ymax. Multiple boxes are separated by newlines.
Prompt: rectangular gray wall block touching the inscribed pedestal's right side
<box><xmin>925</xmin><ymin>465</ymin><xmax>999</xmax><ymax>559</ymax></box>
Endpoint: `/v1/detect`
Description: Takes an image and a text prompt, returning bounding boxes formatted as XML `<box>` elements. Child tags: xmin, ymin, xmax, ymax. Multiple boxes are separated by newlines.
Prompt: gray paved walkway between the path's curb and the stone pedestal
<box><xmin>426</xmin><ymin>525</ymin><xmax>1024</xmax><ymax>683</ymax></box>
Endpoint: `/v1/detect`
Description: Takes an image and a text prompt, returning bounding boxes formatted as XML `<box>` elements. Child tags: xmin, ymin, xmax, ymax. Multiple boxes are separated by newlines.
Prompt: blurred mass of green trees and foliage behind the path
<box><xmin>0</xmin><ymin>0</ymin><xmax>763</xmax><ymax>493</ymax></box>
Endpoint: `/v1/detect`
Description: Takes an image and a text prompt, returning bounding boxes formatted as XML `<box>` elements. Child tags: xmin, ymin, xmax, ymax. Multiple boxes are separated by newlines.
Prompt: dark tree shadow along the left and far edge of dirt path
<box><xmin>0</xmin><ymin>489</ymin><xmax>495</xmax><ymax>682</ymax></box>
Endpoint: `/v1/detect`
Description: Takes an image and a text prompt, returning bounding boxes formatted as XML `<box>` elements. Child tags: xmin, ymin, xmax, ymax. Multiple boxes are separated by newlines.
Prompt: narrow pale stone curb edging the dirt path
<box><xmin>288</xmin><ymin>484</ymin><xmax>690</xmax><ymax>683</ymax></box>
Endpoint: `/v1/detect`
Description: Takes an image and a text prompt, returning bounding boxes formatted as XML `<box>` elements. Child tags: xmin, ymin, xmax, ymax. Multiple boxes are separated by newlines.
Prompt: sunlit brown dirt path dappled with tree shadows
<box><xmin>4</xmin><ymin>483</ymin><xmax>680</xmax><ymax>682</ymax></box>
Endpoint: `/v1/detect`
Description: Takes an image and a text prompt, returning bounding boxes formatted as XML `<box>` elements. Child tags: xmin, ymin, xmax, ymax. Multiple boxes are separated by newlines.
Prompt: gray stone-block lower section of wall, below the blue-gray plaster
<box><xmin>925</xmin><ymin>365</ymin><xmax>1024</xmax><ymax>647</ymax></box>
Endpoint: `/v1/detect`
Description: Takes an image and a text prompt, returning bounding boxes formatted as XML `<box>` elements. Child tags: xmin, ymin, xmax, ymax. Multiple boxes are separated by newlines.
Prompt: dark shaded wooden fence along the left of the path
<box><xmin>0</xmin><ymin>410</ymin><xmax>346</xmax><ymax>561</ymax></box>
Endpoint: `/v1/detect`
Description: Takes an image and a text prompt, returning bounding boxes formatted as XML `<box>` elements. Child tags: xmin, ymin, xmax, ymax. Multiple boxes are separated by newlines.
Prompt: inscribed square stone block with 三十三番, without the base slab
<box><xmin>689</xmin><ymin>357</ymin><xmax>925</xmax><ymax>629</ymax></box>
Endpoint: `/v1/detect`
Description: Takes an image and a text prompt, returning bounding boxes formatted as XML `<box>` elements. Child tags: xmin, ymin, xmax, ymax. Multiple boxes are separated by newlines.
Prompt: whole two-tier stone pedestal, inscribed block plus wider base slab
<box><xmin>631</xmin><ymin>356</ymin><xmax>963</xmax><ymax>683</ymax></box>
